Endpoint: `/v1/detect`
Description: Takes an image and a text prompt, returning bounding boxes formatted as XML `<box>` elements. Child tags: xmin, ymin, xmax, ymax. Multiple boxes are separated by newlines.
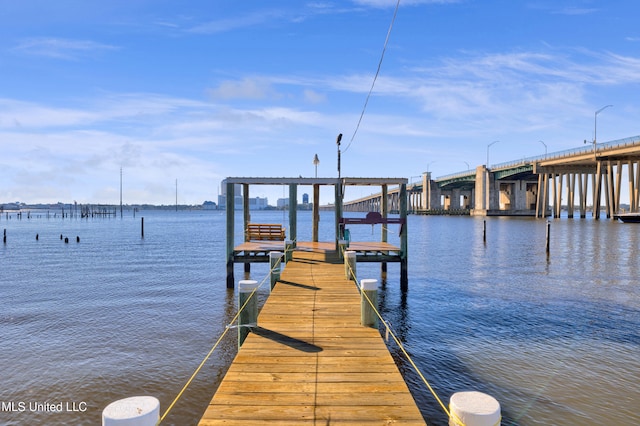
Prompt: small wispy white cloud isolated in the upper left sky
<box><xmin>14</xmin><ymin>37</ymin><xmax>119</xmax><ymax>60</ymax></box>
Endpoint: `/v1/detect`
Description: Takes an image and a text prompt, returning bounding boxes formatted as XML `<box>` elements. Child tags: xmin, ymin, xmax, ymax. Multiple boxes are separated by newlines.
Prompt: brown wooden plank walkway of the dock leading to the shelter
<box><xmin>199</xmin><ymin>248</ymin><xmax>425</xmax><ymax>426</ymax></box>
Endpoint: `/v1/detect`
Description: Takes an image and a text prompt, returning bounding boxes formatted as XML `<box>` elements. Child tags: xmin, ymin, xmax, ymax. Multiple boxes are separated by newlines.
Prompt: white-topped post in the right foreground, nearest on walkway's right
<box><xmin>449</xmin><ymin>391</ymin><xmax>501</xmax><ymax>426</ymax></box>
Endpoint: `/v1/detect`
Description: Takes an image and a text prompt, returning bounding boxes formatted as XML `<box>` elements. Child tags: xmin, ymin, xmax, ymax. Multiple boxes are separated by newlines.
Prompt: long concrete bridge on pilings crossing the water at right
<box><xmin>343</xmin><ymin>136</ymin><xmax>640</xmax><ymax>219</ymax></box>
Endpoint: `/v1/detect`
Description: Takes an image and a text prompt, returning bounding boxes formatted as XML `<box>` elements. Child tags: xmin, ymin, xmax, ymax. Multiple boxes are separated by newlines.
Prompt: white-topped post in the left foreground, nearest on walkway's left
<box><xmin>102</xmin><ymin>396</ymin><xmax>160</xmax><ymax>426</ymax></box>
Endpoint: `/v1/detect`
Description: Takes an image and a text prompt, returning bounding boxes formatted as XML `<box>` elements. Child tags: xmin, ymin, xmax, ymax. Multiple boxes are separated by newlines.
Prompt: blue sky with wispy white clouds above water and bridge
<box><xmin>0</xmin><ymin>0</ymin><xmax>640</xmax><ymax>204</ymax></box>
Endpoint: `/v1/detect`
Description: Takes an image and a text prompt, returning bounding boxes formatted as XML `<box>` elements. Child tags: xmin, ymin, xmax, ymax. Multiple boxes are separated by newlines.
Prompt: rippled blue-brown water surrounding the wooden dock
<box><xmin>0</xmin><ymin>211</ymin><xmax>640</xmax><ymax>425</ymax></box>
